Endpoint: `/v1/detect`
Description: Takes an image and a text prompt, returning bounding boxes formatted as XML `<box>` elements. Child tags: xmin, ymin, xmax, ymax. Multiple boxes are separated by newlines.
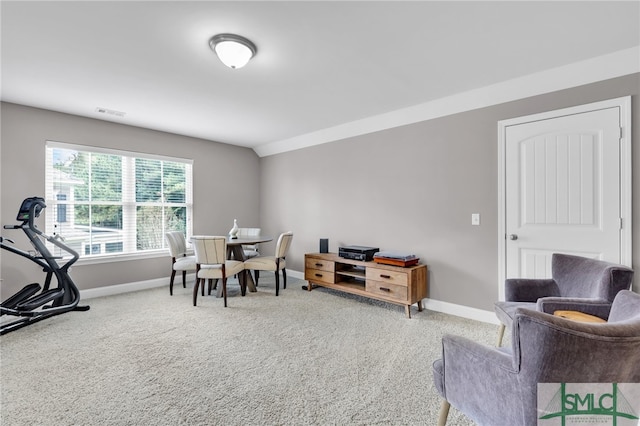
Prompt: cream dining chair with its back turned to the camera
<box><xmin>191</xmin><ymin>235</ymin><xmax>247</xmax><ymax>308</ymax></box>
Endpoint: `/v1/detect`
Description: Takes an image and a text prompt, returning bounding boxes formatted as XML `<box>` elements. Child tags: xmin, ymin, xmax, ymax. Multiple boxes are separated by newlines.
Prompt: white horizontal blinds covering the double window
<box><xmin>45</xmin><ymin>141</ymin><xmax>193</xmax><ymax>257</ymax></box>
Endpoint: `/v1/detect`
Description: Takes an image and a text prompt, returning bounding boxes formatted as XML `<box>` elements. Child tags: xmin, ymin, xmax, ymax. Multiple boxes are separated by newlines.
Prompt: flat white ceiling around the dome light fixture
<box><xmin>1</xmin><ymin>1</ymin><xmax>640</xmax><ymax>154</ymax></box>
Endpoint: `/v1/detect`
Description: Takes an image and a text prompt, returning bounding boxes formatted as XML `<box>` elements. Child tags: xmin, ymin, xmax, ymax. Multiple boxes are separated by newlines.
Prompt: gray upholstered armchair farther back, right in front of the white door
<box><xmin>495</xmin><ymin>253</ymin><xmax>633</xmax><ymax>346</ymax></box>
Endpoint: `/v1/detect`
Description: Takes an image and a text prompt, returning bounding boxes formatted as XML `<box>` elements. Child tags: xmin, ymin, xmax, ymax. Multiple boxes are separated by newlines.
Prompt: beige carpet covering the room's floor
<box><xmin>0</xmin><ymin>274</ymin><xmax>497</xmax><ymax>426</ymax></box>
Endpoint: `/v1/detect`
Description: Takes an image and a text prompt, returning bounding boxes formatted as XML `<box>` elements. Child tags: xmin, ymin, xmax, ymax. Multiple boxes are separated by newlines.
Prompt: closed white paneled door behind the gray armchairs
<box><xmin>500</xmin><ymin>96</ymin><xmax>631</xmax><ymax>296</ymax></box>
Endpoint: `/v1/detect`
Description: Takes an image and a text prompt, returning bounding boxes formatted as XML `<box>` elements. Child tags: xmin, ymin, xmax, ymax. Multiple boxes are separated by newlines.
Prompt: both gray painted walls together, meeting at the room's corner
<box><xmin>0</xmin><ymin>74</ymin><xmax>640</xmax><ymax>310</ymax></box>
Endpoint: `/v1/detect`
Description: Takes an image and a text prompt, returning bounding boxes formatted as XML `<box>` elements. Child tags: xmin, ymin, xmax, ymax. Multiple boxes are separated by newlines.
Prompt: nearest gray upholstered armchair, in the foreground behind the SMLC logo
<box><xmin>433</xmin><ymin>290</ymin><xmax>640</xmax><ymax>426</ymax></box>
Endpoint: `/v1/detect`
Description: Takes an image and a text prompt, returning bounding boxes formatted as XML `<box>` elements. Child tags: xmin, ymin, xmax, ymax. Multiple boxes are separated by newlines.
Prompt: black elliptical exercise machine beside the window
<box><xmin>0</xmin><ymin>197</ymin><xmax>89</xmax><ymax>335</ymax></box>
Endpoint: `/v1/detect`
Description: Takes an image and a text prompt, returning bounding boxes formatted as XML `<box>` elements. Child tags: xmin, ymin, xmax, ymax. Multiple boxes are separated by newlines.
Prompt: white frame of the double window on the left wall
<box><xmin>44</xmin><ymin>141</ymin><xmax>193</xmax><ymax>264</ymax></box>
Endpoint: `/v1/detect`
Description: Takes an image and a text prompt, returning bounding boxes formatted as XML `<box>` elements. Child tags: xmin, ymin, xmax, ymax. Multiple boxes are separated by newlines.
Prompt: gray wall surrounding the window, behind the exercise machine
<box><xmin>0</xmin><ymin>103</ymin><xmax>260</xmax><ymax>299</ymax></box>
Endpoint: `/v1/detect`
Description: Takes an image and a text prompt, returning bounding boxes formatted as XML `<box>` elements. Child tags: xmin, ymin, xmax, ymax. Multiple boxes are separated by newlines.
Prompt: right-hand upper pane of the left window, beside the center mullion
<box><xmin>91</xmin><ymin>154</ymin><xmax>122</xmax><ymax>201</ymax></box>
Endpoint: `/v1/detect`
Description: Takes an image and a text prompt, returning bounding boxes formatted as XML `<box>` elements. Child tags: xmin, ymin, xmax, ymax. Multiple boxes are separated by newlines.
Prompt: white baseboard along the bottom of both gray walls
<box><xmin>80</xmin><ymin>270</ymin><xmax>499</xmax><ymax>325</ymax></box>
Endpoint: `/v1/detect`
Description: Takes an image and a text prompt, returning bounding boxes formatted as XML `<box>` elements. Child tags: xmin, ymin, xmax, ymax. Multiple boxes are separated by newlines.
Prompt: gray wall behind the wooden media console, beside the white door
<box><xmin>260</xmin><ymin>74</ymin><xmax>640</xmax><ymax>311</ymax></box>
